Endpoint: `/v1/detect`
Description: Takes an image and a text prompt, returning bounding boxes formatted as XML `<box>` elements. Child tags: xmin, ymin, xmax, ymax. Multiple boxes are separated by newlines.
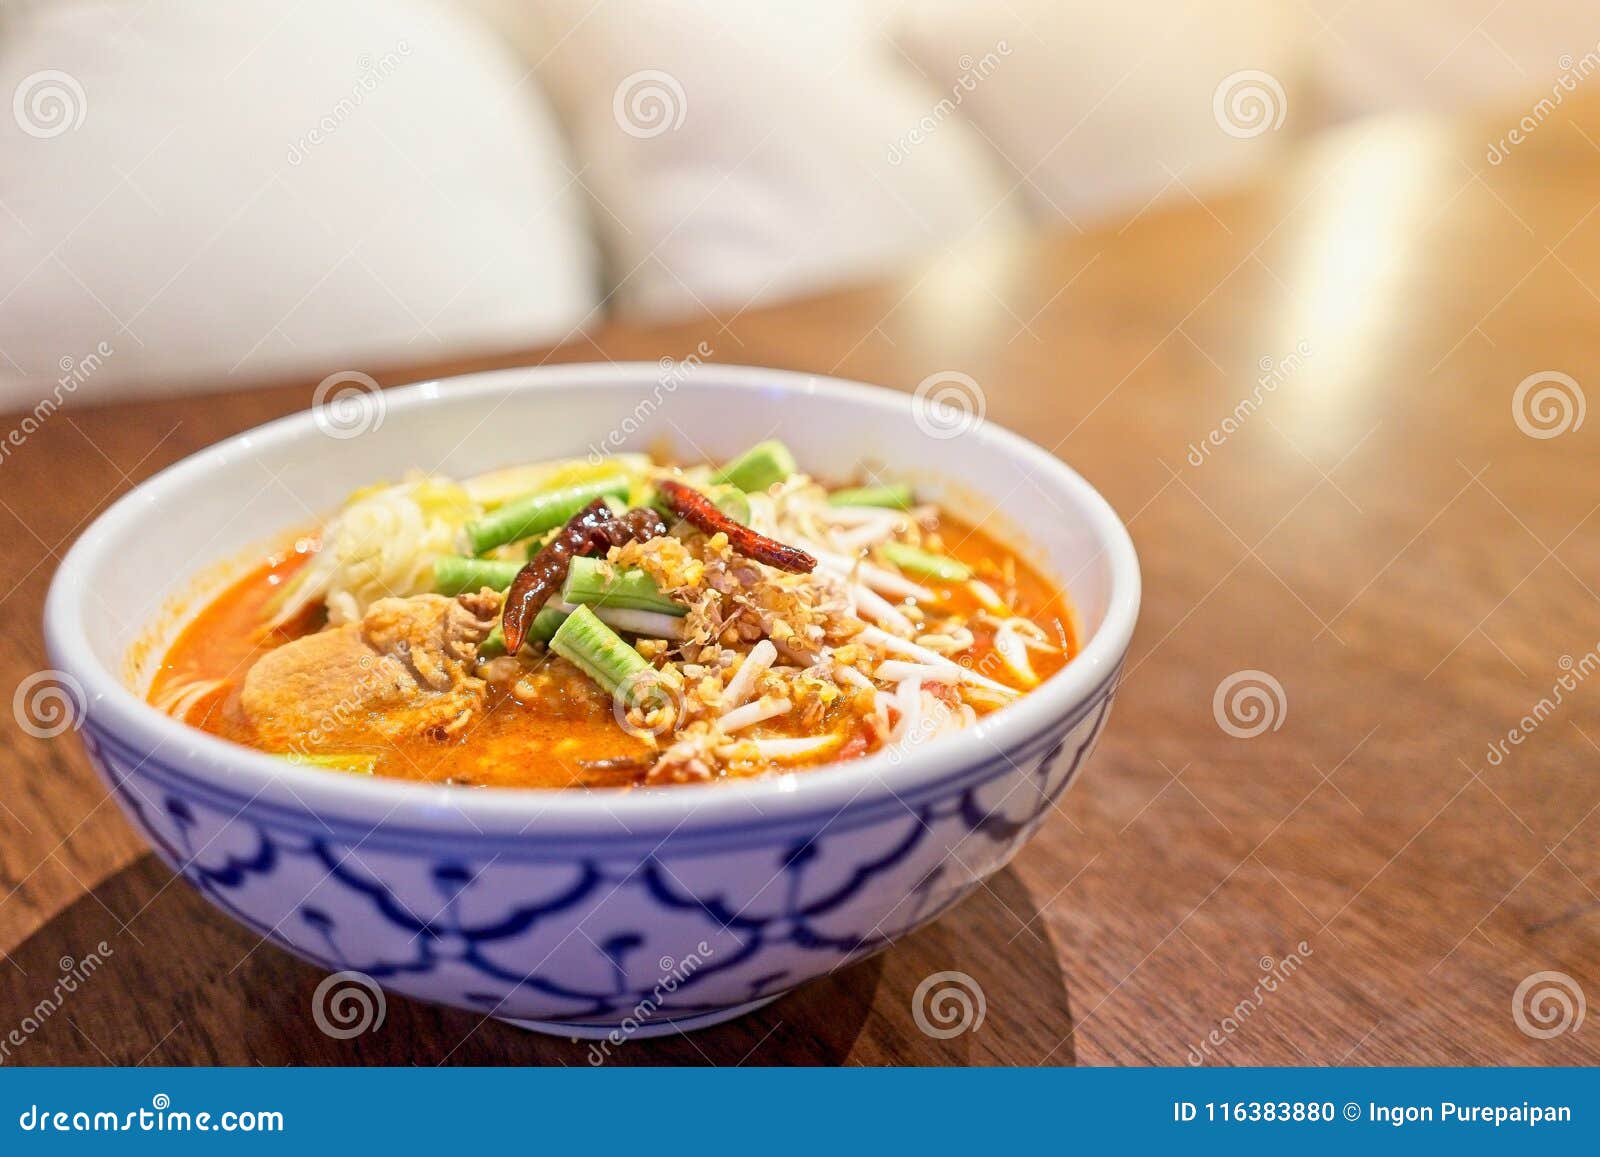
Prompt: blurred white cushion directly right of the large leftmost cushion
<box><xmin>512</xmin><ymin>0</ymin><xmax>1019</xmax><ymax>314</ymax></box>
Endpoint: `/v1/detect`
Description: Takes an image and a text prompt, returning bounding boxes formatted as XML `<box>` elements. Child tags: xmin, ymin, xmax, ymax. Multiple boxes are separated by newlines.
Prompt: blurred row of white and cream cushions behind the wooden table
<box><xmin>0</xmin><ymin>0</ymin><xmax>1600</xmax><ymax>410</ymax></box>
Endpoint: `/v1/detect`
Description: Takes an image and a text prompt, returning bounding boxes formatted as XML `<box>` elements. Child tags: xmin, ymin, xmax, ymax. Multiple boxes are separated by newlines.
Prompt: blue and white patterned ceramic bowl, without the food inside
<box><xmin>45</xmin><ymin>363</ymin><xmax>1139</xmax><ymax>1037</ymax></box>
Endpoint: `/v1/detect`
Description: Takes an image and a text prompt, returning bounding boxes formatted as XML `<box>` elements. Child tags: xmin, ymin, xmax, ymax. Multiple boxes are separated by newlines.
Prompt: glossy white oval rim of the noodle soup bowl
<box><xmin>45</xmin><ymin>362</ymin><xmax>1141</xmax><ymax>840</ymax></box>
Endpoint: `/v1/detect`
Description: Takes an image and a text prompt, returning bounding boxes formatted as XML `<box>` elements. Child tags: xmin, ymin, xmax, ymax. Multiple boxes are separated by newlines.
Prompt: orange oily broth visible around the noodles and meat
<box><xmin>149</xmin><ymin>515</ymin><xmax>1078</xmax><ymax>787</ymax></box>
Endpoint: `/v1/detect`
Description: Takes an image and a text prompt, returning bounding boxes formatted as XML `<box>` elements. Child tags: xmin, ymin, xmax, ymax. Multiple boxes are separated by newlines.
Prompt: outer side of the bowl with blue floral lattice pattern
<box><xmin>83</xmin><ymin>674</ymin><xmax>1117</xmax><ymax>1035</ymax></box>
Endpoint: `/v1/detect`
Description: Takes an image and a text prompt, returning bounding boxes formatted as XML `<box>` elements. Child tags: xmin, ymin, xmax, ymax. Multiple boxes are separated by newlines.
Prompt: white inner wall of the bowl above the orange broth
<box><xmin>80</xmin><ymin>365</ymin><xmax>1112</xmax><ymax>690</ymax></box>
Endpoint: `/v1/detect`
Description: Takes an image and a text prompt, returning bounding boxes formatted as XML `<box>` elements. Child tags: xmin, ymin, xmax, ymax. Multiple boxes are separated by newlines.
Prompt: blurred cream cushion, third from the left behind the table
<box><xmin>890</xmin><ymin>0</ymin><xmax>1304</xmax><ymax>219</ymax></box>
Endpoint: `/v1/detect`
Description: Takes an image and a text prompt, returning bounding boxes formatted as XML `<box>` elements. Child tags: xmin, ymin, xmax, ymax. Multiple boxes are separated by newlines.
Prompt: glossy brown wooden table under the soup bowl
<box><xmin>0</xmin><ymin>102</ymin><xmax>1600</xmax><ymax>1064</ymax></box>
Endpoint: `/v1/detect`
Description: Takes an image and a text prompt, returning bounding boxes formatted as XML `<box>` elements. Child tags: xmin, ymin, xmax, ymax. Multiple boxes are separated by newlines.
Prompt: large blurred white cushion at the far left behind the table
<box><xmin>0</xmin><ymin>0</ymin><xmax>598</xmax><ymax>406</ymax></box>
